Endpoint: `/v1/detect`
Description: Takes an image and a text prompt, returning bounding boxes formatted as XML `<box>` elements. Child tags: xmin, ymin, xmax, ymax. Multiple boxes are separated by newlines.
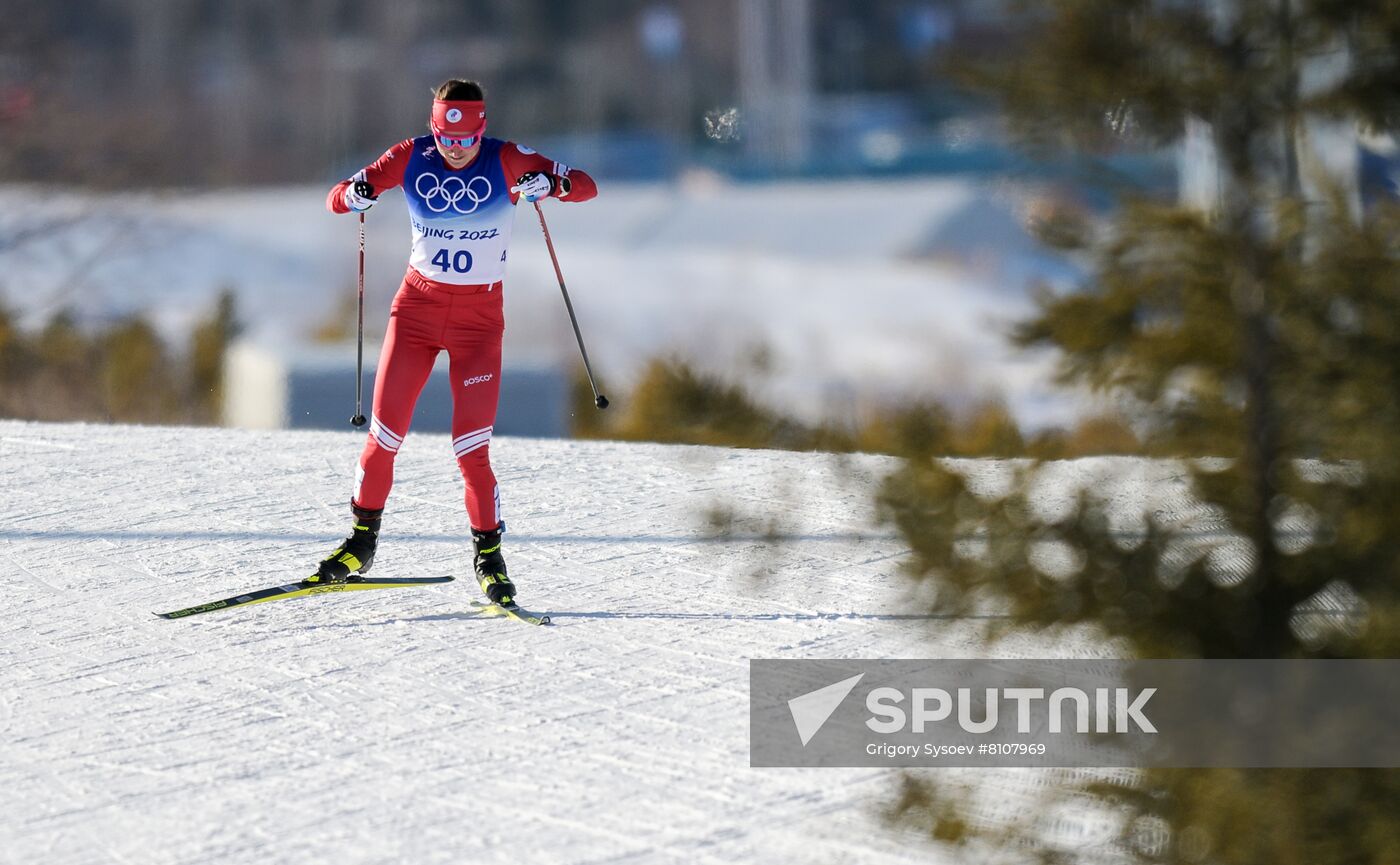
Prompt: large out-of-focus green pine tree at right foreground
<box><xmin>882</xmin><ymin>0</ymin><xmax>1400</xmax><ymax>865</ymax></box>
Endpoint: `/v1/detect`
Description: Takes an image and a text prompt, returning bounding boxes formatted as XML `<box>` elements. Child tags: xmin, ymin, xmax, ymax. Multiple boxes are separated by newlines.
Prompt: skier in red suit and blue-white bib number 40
<box><xmin>307</xmin><ymin>78</ymin><xmax>598</xmax><ymax>605</ymax></box>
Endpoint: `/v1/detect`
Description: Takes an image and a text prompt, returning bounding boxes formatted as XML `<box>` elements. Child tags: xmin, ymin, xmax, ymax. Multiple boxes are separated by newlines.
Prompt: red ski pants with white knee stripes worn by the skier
<box><xmin>354</xmin><ymin>270</ymin><xmax>505</xmax><ymax>532</ymax></box>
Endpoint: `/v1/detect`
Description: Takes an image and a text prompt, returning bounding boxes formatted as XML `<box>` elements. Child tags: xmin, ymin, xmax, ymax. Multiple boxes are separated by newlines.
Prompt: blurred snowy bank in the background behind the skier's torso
<box><xmin>0</xmin><ymin>175</ymin><xmax>1084</xmax><ymax>427</ymax></box>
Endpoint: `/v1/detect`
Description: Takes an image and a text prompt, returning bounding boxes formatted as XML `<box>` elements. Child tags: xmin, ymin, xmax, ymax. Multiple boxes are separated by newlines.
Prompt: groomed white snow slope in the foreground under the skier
<box><xmin>0</xmin><ymin>421</ymin><xmax>1192</xmax><ymax>865</ymax></box>
